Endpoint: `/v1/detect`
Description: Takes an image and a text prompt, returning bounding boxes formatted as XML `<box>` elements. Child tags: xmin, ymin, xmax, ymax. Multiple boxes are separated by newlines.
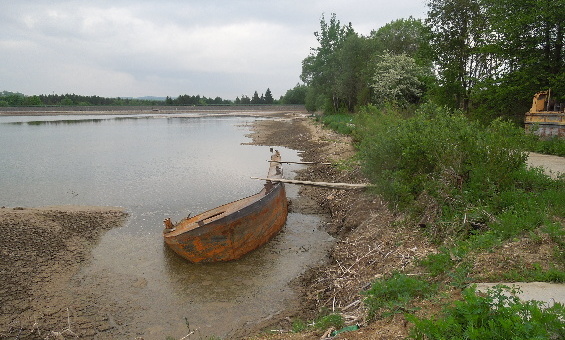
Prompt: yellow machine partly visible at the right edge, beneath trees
<box><xmin>524</xmin><ymin>90</ymin><xmax>565</xmax><ymax>138</ymax></box>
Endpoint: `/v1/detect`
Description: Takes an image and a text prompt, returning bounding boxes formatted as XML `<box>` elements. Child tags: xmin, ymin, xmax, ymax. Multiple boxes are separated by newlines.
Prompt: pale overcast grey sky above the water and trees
<box><xmin>0</xmin><ymin>0</ymin><xmax>426</xmax><ymax>100</ymax></box>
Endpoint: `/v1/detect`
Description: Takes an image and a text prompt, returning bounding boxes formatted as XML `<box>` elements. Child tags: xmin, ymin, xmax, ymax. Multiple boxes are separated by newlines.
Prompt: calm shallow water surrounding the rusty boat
<box><xmin>0</xmin><ymin>114</ymin><xmax>332</xmax><ymax>339</ymax></box>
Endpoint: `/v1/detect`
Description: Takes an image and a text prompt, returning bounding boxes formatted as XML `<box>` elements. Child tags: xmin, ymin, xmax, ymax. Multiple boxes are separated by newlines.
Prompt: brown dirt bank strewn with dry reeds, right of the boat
<box><xmin>245</xmin><ymin>117</ymin><xmax>435</xmax><ymax>339</ymax></box>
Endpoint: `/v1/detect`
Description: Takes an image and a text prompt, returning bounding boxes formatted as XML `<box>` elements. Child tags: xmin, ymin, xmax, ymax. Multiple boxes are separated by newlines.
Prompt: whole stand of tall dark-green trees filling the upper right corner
<box><xmin>426</xmin><ymin>0</ymin><xmax>565</xmax><ymax>118</ymax></box>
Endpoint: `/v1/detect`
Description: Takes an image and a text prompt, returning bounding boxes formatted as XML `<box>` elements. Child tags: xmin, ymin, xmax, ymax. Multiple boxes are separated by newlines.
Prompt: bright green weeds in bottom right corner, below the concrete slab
<box><xmin>409</xmin><ymin>286</ymin><xmax>565</xmax><ymax>339</ymax></box>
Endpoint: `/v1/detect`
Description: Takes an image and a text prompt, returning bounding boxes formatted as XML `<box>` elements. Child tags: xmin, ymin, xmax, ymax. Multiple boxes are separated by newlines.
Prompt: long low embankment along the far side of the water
<box><xmin>0</xmin><ymin>105</ymin><xmax>307</xmax><ymax>116</ymax></box>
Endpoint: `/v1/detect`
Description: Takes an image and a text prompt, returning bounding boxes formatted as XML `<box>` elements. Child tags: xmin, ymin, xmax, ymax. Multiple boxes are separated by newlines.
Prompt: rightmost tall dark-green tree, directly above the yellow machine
<box><xmin>476</xmin><ymin>0</ymin><xmax>565</xmax><ymax>121</ymax></box>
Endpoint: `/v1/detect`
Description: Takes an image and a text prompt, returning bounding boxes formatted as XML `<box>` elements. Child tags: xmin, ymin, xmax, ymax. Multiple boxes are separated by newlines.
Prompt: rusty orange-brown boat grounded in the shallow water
<box><xmin>163</xmin><ymin>151</ymin><xmax>288</xmax><ymax>262</ymax></box>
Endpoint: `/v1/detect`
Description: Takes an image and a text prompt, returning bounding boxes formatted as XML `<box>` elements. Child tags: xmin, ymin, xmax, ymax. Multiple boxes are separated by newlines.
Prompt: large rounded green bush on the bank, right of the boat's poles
<box><xmin>355</xmin><ymin>106</ymin><xmax>526</xmax><ymax>210</ymax></box>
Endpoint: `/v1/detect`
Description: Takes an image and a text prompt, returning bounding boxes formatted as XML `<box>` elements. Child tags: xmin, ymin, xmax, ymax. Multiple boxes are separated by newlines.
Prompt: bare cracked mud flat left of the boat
<box><xmin>0</xmin><ymin>206</ymin><xmax>126</xmax><ymax>339</ymax></box>
